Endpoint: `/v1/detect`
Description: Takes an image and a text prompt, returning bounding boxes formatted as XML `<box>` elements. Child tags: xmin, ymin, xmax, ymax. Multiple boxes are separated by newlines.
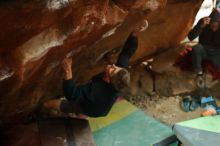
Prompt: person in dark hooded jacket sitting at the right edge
<box><xmin>188</xmin><ymin>9</ymin><xmax>220</xmax><ymax>84</ymax></box>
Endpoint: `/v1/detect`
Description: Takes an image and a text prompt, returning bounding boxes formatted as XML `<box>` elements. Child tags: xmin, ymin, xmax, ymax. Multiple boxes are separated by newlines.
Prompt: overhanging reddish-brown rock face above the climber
<box><xmin>0</xmin><ymin>0</ymin><xmax>202</xmax><ymax>127</ymax></box>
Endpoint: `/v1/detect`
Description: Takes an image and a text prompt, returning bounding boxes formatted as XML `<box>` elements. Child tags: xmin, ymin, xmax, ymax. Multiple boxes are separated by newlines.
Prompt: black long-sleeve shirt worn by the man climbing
<box><xmin>63</xmin><ymin>35</ymin><xmax>137</xmax><ymax>117</ymax></box>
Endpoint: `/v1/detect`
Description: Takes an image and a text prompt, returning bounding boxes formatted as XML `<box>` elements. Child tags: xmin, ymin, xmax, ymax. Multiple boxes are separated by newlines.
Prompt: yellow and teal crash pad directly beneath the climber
<box><xmin>88</xmin><ymin>100</ymin><xmax>176</xmax><ymax>146</ymax></box>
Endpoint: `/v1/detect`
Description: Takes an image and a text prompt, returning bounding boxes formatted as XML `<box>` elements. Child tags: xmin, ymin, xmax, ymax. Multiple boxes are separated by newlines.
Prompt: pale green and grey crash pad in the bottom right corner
<box><xmin>173</xmin><ymin>115</ymin><xmax>220</xmax><ymax>146</ymax></box>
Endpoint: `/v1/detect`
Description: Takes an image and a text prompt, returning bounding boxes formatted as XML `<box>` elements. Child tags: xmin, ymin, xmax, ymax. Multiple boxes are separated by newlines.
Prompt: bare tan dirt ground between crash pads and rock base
<box><xmin>130</xmin><ymin>95</ymin><xmax>220</xmax><ymax>125</ymax></box>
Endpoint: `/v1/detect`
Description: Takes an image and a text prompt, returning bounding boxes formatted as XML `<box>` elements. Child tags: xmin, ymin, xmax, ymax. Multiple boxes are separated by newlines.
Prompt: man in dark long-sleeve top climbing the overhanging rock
<box><xmin>44</xmin><ymin>21</ymin><xmax>147</xmax><ymax>117</ymax></box>
